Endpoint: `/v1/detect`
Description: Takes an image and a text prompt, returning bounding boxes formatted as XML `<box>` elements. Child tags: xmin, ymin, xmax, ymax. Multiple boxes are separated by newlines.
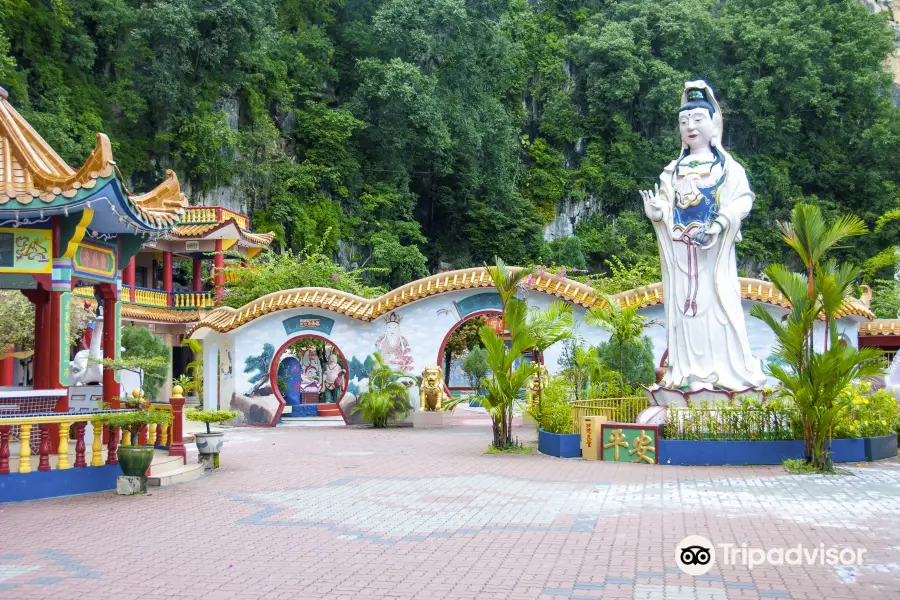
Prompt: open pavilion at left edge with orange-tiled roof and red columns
<box><xmin>0</xmin><ymin>88</ymin><xmax>187</xmax><ymax>413</ymax></box>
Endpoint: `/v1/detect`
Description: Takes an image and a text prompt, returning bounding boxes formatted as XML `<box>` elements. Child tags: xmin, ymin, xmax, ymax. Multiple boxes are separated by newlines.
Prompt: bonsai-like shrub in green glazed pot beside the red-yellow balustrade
<box><xmin>100</xmin><ymin>390</ymin><xmax>172</xmax><ymax>491</ymax></box>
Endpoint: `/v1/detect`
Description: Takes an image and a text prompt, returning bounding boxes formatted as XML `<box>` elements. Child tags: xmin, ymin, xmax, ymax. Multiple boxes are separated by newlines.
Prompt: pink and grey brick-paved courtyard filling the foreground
<box><xmin>0</xmin><ymin>415</ymin><xmax>900</xmax><ymax>600</ymax></box>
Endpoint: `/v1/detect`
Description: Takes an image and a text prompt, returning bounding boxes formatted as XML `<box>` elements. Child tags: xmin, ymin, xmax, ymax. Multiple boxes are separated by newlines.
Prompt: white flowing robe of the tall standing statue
<box><xmin>653</xmin><ymin>152</ymin><xmax>766</xmax><ymax>390</ymax></box>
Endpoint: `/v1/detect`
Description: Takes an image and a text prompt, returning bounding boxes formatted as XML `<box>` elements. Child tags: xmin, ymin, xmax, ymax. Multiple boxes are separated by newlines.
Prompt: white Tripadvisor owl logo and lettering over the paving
<box><xmin>675</xmin><ymin>535</ymin><xmax>867</xmax><ymax>576</ymax></box>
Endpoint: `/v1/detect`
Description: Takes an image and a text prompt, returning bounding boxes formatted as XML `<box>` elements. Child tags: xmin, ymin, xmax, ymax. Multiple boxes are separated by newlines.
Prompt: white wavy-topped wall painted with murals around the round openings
<box><xmin>205</xmin><ymin>289</ymin><xmax>856</xmax><ymax>424</ymax></box>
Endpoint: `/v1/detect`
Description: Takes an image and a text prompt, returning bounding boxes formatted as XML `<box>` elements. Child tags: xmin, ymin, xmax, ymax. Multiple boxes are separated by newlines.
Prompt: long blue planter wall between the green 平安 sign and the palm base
<box><xmin>659</xmin><ymin>440</ymin><xmax>804</xmax><ymax>466</ymax></box>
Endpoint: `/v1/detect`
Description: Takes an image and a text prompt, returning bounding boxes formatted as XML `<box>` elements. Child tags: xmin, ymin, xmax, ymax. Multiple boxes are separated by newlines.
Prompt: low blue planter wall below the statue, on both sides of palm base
<box><xmin>659</xmin><ymin>433</ymin><xmax>897</xmax><ymax>466</ymax></box>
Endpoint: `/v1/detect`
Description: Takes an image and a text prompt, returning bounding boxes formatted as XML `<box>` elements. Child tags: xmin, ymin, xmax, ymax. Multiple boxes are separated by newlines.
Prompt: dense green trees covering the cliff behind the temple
<box><xmin>0</xmin><ymin>0</ymin><xmax>900</xmax><ymax>286</ymax></box>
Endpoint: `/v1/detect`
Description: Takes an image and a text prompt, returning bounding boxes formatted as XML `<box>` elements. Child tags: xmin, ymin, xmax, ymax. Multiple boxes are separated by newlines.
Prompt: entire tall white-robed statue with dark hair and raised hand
<box><xmin>641</xmin><ymin>81</ymin><xmax>765</xmax><ymax>390</ymax></box>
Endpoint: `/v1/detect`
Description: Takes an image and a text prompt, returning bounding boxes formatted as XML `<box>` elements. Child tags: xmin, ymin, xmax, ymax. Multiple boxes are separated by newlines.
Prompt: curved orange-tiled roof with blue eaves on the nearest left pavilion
<box><xmin>0</xmin><ymin>88</ymin><xmax>187</xmax><ymax>233</ymax></box>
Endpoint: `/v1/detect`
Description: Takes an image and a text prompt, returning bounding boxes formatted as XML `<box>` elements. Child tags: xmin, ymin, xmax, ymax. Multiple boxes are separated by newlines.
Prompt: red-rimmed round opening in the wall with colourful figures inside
<box><xmin>269</xmin><ymin>333</ymin><xmax>350</xmax><ymax>421</ymax></box>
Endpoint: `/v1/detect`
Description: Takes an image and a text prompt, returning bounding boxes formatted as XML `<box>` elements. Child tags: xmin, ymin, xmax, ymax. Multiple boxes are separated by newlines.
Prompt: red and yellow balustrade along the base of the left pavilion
<box><xmin>0</xmin><ymin>410</ymin><xmax>129</xmax><ymax>475</ymax></box>
